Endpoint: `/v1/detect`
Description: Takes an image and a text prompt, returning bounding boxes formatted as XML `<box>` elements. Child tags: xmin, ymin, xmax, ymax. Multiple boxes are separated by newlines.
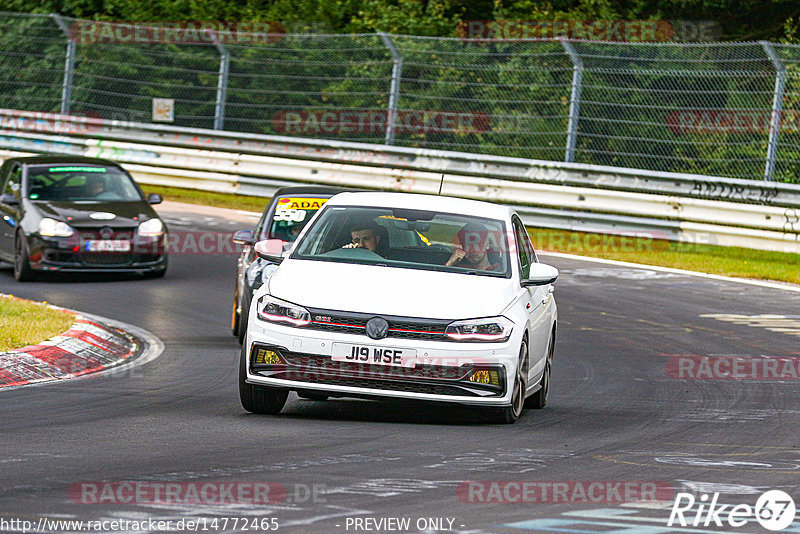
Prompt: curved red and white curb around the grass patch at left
<box><xmin>0</xmin><ymin>298</ymin><xmax>164</xmax><ymax>389</ymax></box>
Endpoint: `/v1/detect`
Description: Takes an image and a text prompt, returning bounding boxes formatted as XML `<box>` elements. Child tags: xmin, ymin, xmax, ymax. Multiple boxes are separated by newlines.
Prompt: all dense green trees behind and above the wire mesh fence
<box><xmin>0</xmin><ymin>0</ymin><xmax>800</xmax><ymax>181</ymax></box>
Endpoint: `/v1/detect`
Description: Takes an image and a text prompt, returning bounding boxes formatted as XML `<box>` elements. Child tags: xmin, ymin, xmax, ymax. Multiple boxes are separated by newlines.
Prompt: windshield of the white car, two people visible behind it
<box><xmin>292</xmin><ymin>206</ymin><xmax>511</xmax><ymax>278</ymax></box>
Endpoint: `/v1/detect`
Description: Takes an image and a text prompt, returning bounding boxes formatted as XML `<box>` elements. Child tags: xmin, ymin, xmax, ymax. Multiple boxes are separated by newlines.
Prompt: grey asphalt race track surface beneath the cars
<box><xmin>0</xmin><ymin>203</ymin><xmax>800</xmax><ymax>534</ymax></box>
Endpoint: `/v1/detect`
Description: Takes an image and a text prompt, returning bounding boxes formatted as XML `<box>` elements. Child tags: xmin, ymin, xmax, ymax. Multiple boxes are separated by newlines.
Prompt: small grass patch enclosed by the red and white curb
<box><xmin>0</xmin><ymin>297</ymin><xmax>75</xmax><ymax>352</ymax></box>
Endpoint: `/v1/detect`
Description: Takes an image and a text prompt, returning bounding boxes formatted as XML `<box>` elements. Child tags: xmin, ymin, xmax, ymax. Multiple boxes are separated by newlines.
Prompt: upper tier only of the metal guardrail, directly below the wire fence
<box><xmin>0</xmin><ymin>109</ymin><xmax>800</xmax><ymax>208</ymax></box>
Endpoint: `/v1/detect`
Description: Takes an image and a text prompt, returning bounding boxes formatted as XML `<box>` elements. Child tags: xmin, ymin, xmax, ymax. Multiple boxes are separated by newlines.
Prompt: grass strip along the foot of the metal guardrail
<box><xmin>142</xmin><ymin>185</ymin><xmax>800</xmax><ymax>284</ymax></box>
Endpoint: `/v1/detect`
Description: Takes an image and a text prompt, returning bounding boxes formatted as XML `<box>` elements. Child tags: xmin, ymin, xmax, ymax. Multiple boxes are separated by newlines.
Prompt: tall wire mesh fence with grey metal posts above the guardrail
<box><xmin>0</xmin><ymin>13</ymin><xmax>800</xmax><ymax>183</ymax></box>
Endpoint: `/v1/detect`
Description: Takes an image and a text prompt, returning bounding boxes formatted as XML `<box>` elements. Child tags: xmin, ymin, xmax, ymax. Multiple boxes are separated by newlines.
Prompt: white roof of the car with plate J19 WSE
<box><xmin>328</xmin><ymin>192</ymin><xmax>513</xmax><ymax>220</ymax></box>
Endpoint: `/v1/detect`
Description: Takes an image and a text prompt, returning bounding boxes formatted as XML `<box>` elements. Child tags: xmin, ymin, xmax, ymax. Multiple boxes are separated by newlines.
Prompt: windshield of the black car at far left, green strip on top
<box><xmin>27</xmin><ymin>164</ymin><xmax>143</xmax><ymax>202</ymax></box>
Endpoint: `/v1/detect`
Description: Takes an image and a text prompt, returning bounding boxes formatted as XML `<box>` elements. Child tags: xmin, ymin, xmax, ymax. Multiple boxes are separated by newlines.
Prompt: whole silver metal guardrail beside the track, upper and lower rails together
<box><xmin>0</xmin><ymin>110</ymin><xmax>800</xmax><ymax>252</ymax></box>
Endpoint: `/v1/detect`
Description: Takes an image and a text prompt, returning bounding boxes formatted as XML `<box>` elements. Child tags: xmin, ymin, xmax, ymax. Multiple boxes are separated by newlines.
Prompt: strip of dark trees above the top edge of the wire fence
<box><xmin>3</xmin><ymin>0</ymin><xmax>800</xmax><ymax>41</ymax></box>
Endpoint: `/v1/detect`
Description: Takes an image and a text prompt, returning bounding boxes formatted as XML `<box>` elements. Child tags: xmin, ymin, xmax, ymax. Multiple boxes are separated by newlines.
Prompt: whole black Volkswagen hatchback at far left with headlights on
<box><xmin>0</xmin><ymin>156</ymin><xmax>167</xmax><ymax>281</ymax></box>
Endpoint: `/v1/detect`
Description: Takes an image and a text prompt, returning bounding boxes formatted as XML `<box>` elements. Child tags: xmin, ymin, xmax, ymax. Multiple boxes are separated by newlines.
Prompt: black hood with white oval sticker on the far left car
<box><xmin>33</xmin><ymin>200</ymin><xmax>156</xmax><ymax>228</ymax></box>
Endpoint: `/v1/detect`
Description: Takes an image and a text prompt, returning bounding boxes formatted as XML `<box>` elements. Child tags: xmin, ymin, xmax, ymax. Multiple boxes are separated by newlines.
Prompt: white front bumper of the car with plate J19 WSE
<box><xmin>245</xmin><ymin>320</ymin><xmax>519</xmax><ymax>407</ymax></box>
